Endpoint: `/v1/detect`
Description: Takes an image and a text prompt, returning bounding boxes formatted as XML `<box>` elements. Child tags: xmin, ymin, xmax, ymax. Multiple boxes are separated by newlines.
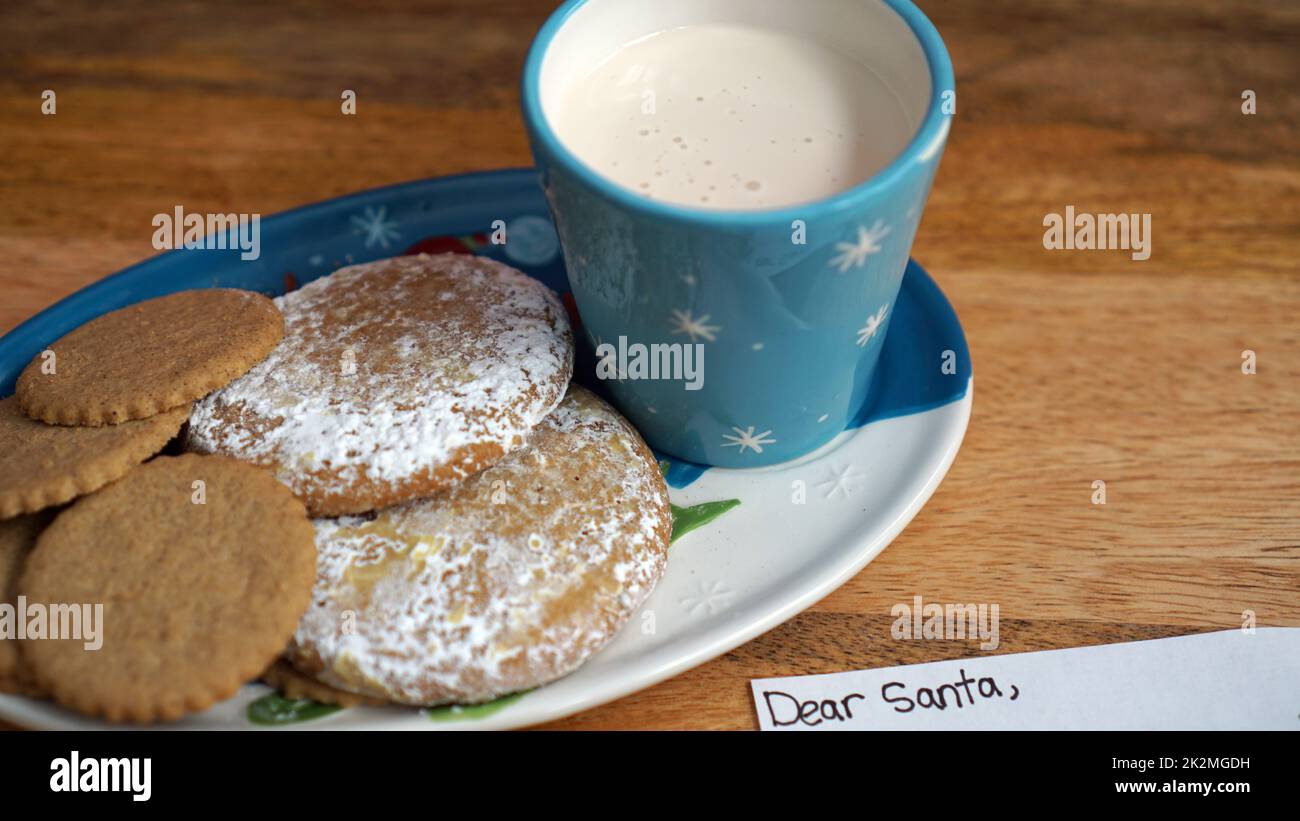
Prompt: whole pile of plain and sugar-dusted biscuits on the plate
<box><xmin>0</xmin><ymin>255</ymin><xmax>672</xmax><ymax>722</ymax></box>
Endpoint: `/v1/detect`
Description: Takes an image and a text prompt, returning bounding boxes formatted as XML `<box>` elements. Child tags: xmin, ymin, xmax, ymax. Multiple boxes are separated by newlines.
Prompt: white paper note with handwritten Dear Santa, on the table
<box><xmin>750</xmin><ymin>627</ymin><xmax>1300</xmax><ymax>730</ymax></box>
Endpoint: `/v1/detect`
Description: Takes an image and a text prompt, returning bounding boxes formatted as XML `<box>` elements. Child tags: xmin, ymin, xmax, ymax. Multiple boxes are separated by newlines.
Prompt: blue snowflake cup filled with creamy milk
<box><xmin>523</xmin><ymin>0</ymin><xmax>954</xmax><ymax>468</ymax></box>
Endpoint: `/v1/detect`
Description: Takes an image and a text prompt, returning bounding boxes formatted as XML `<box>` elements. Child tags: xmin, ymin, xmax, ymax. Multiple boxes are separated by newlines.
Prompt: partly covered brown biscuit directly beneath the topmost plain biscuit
<box><xmin>0</xmin><ymin>396</ymin><xmax>190</xmax><ymax>520</ymax></box>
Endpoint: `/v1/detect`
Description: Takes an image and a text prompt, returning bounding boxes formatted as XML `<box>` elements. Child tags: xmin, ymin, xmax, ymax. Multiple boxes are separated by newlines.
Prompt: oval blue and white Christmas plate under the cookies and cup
<box><xmin>0</xmin><ymin>169</ymin><xmax>972</xmax><ymax>730</ymax></box>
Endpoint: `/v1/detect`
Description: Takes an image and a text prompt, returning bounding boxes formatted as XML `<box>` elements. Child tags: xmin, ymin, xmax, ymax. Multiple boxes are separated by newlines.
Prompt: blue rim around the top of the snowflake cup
<box><xmin>520</xmin><ymin>0</ymin><xmax>956</xmax><ymax>227</ymax></box>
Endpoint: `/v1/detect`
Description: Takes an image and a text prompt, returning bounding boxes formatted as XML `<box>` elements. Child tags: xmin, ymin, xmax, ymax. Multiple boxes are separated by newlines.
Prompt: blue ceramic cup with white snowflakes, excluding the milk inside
<box><xmin>523</xmin><ymin>0</ymin><xmax>954</xmax><ymax>468</ymax></box>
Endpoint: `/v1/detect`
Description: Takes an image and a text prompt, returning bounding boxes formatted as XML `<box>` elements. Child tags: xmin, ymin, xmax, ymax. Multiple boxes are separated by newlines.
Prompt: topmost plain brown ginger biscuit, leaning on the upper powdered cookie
<box><xmin>18</xmin><ymin>288</ymin><xmax>285</xmax><ymax>425</ymax></box>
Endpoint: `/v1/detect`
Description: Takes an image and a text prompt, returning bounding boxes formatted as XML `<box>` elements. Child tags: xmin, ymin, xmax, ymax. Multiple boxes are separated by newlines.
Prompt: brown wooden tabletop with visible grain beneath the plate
<box><xmin>0</xmin><ymin>0</ymin><xmax>1300</xmax><ymax>729</ymax></box>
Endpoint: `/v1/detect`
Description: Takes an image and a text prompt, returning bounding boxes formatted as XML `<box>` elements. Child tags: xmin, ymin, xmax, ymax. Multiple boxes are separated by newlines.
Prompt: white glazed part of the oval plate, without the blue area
<box><xmin>0</xmin><ymin>385</ymin><xmax>974</xmax><ymax>730</ymax></box>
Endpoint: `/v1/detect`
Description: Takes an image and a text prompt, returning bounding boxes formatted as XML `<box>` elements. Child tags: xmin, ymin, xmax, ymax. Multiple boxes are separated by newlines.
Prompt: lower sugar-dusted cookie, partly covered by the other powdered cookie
<box><xmin>286</xmin><ymin>386</ymin><xmax>672</xmax><ymax>704</ymax></box>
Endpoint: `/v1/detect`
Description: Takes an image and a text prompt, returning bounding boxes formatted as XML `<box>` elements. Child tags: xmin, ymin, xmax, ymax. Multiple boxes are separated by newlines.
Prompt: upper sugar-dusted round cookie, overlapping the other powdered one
<box><xmin>189</xmin><ymin>253</ymin><xmax>573</xmax><ymax>516</ymax></box>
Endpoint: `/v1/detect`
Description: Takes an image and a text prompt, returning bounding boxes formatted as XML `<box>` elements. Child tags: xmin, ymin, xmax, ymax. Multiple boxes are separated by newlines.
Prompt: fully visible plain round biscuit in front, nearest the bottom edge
<box><xmin>17</xmin><ymin>453</ymin><xmax>316</xmax><ymax>722</ymax></box>
